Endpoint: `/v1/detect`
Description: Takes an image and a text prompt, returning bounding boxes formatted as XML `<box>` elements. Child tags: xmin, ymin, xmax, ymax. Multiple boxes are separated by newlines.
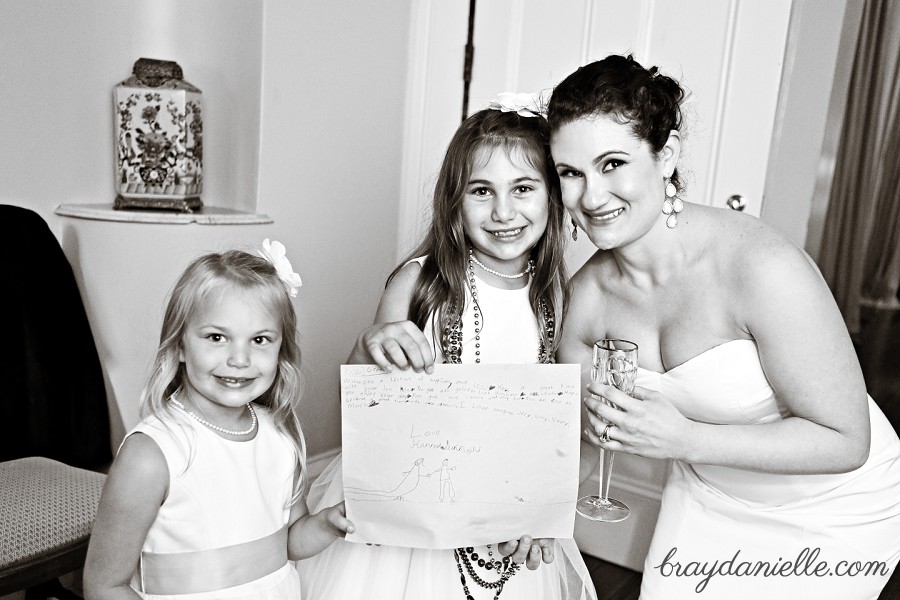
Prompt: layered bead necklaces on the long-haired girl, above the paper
<box><xmin>442</xmin><ymin>248</ymin><xmax>555</xmax><ymax>364</ymax></box>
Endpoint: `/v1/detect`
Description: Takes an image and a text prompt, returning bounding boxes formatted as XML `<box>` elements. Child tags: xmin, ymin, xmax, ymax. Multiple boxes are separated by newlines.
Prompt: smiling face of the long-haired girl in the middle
<box><xmin>462</xmin><ymin>147</ymin><xmax>550</xmax><ymax>275</ymax></box>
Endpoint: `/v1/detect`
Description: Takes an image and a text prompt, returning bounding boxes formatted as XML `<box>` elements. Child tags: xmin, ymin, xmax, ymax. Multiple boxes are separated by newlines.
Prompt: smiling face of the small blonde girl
<box><xmin>179</xmin><ymin>287</ymin><xmax>282</xmax><ymax>427</ymax></box>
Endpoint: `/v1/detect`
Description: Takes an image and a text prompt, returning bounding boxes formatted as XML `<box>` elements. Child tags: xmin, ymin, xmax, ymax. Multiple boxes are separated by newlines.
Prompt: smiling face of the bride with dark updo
<box><xmin>550</xmin><ymin>115</ymin><xmax>680</xmax><ymax>250</ymax></box>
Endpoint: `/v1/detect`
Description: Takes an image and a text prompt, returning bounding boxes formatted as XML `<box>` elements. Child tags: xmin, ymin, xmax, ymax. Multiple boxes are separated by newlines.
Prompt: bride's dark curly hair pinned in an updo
<box><xmin>547</xmin><ymin>54</ymin><xmax>685</xmax><ymax>190</ymax></box>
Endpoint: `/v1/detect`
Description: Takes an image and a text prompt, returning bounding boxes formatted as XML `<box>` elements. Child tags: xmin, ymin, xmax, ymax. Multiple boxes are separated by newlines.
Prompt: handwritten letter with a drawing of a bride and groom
<box><xmin>341</xmin><ymin>365</ymin><xmax>581</xmax><ymax>548</ymax></box>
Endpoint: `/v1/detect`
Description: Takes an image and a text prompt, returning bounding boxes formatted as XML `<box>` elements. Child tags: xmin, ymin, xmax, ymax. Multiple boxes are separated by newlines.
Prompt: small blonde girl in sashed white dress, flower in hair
<box><xmin>84</xmin><ymin>240</ymin><xmax>352</xmax><ymax>600</ymax></box>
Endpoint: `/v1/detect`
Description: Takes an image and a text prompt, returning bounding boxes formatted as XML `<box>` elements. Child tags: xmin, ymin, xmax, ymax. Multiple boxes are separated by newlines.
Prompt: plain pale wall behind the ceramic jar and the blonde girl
<box><xmin>0</xmin><ymin>0</ymin><xmax>411</xmax><ymax>454</ymax></box>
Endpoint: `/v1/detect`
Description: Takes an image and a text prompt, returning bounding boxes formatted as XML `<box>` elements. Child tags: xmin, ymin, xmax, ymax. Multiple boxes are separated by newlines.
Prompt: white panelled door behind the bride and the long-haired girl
<box><xmin>398</xmin><ymin>0</ymin><xmax>791</xmax><ymax>570</ymax></box>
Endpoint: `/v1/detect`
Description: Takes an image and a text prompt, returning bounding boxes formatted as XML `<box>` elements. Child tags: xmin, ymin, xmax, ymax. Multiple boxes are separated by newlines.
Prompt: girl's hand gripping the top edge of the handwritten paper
<box><xmin>349</xmin><ymin>321</ymin><xmax>434</xmax><ymax>373</ymax></box>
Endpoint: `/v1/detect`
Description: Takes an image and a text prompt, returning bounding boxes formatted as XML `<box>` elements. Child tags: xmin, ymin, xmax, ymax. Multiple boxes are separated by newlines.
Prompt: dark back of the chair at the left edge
<box><xmin>0</xmin><ymin>205</ymin><xmax>112</xmax><ymax>468</ymax></box>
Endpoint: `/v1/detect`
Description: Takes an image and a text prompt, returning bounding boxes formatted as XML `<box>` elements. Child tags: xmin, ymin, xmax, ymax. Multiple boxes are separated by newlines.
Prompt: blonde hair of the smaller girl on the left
<box><xmin>141</xmin><ymin>250</ymin><xmax>306</xmax><ymax>504</ymax></box>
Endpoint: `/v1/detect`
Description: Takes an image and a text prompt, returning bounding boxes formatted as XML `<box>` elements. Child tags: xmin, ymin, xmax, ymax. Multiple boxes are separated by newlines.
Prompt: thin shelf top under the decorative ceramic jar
<box><xmin>54</xmin><ymin>204</ymin><xmax>274</xmax><ymax>225</ymax></box>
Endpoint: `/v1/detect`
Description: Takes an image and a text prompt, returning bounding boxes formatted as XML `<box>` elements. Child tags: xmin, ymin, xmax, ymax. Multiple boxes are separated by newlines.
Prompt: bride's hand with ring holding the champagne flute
<box><xmin>584</xmin><ymin>382</ymin><xmax>694</xmax><ymax>459</ymax></box>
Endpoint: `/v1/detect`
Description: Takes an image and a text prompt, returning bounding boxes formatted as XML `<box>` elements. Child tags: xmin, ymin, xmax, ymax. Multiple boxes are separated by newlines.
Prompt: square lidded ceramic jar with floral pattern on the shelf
<box><xmin>114</xmin><ymin>58</ymin><xmax>203</xmax><ymax>212</ymax></box>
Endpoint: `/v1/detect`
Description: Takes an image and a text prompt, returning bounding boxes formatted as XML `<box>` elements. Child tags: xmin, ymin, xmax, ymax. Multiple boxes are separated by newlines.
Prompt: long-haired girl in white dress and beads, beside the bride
<box><xmin>298</xmin><ymin>95</ymin><xmax>596</xmax><ymax>600</ymax></box>
